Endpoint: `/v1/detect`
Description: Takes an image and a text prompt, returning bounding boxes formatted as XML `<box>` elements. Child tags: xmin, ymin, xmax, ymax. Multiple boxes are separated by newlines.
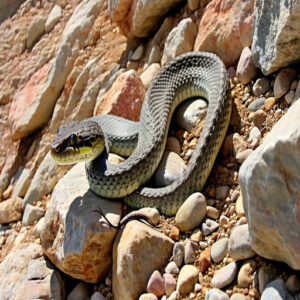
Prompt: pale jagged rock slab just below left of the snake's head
<box><xmin>22</xmin><ymin>151</ymin><xmax>59</xmax><ymax>208</ymax></box>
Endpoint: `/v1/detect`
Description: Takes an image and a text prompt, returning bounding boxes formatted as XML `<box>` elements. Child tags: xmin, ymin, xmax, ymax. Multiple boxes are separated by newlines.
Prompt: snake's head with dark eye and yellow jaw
<box><xmin>51</xmin><ymin>120</ymin><xmax>105</xmax><ymax>165</ymax></box>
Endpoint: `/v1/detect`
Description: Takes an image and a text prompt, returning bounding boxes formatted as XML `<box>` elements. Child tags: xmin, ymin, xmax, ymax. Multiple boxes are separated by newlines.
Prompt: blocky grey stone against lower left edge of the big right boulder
<box><xmin>228</xmin><ymin>224</ymin><xmax>255</xmax><ymax>260</ymax></box>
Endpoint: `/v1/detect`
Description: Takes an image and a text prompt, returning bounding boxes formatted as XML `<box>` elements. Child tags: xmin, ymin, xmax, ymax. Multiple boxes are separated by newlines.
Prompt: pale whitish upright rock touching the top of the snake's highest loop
<box><xmin>161</xmin><ymin>18</ymin><xmax>197</xmax><ymax>65</ymax></box>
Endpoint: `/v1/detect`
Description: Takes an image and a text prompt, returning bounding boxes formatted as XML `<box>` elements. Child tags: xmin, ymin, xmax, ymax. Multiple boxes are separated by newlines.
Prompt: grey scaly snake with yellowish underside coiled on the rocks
<box><xmin>51</xmin><ymin>52</ymin><xmax>232</xmax><ymax>216</ymax></box>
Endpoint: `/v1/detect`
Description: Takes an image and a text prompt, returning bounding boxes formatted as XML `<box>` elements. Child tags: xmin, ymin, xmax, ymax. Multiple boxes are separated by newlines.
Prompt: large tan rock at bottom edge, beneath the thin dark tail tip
<box><xmin>113</xmin><ymin>221</ymin><xmax>174</xmax><ymax>300</ymax></box>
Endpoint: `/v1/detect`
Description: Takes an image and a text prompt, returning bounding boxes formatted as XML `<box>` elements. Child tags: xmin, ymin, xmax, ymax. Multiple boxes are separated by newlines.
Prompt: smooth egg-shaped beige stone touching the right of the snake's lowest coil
<box><xmin>175</xmin><ymin>193</ymin><xmax>206</xmax><ymax>231</ymax></box>
